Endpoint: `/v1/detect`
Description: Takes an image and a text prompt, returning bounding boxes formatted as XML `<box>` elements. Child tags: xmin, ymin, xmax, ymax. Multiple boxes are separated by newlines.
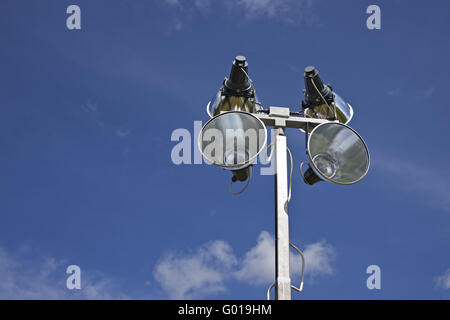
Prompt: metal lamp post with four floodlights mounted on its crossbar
<box><xmin>199</xmin><ymin>56</ymin><xmax>369</xmax><ymax>300</ymax></box>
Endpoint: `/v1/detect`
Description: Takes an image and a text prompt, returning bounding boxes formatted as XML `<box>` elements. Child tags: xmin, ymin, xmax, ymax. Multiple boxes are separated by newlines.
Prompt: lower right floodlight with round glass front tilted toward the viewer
<box><xmin>302</xmin><ymin>122</ymin><xmax>370</xmax><ymax>185</ymax></box>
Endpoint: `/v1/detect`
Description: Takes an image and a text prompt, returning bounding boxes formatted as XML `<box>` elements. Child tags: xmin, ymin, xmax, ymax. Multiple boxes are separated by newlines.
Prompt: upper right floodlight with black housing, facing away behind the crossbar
<box><xmin>302</xmin><ymin>66</ymin><xmax>353</xmax><ymax>124</ymax></box>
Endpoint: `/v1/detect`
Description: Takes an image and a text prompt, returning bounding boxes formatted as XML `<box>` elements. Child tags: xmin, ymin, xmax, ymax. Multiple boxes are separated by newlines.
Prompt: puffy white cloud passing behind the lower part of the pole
<box><xmin>154</xmin><ymin>231</ymin><xmax>335</xmax><ymax>299</ymax></box>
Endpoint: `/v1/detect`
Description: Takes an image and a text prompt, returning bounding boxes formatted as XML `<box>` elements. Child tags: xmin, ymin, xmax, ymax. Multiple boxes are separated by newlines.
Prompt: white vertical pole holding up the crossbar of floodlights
<box><xmin>274</xmin><ymin>128</ymin><xmax>291</xmax><ymax>300</ymax></box>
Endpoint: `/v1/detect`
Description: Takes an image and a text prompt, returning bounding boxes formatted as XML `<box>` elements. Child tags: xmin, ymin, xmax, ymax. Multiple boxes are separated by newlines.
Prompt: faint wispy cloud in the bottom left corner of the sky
<box><xmin>0</xmin><ymin>248</ymin><xmax>127</xmax><ymax>300</ymax></box>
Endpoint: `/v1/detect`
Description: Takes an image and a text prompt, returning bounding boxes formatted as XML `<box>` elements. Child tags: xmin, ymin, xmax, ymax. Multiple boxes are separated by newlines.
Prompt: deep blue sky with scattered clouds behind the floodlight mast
<box><xmin>0</xmin><ymin>0</ymin><xmax>450</xmax><ymax>299</ymax></box>
